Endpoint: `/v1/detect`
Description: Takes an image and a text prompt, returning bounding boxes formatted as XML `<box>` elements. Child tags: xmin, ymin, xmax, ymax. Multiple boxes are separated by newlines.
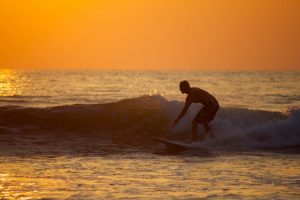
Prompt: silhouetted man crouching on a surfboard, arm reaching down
<box><xmin>172</xmin><ymin>80</ymin><xmax>219</xmax><ymax>141</ymax></box>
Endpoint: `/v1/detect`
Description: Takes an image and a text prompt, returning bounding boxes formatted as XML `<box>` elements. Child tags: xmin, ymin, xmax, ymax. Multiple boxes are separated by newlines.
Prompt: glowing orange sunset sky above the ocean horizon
<box><xmin>0</xmin><ymin>0</ymin><xmax>300</xmax><ymax>70</ymax></box>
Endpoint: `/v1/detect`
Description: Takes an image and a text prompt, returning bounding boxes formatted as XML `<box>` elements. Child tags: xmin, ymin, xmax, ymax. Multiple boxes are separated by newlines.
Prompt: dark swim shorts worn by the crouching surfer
<box><xmin>193</xmin><ymin>104</ymin><xmax>219</xmax><ymax>123</ymax></box>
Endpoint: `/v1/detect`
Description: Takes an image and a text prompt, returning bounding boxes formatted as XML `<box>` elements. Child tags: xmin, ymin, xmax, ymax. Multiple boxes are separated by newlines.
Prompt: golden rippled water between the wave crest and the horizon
<box><xmin>0</xmin><ymin>70</ymin><xmax>300</xmax><ymax>111</ymax></box>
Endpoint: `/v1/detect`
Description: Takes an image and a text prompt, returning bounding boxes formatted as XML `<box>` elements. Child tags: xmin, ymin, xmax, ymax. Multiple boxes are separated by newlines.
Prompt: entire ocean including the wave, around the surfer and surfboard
<box><xmin>0</xmin><ymin>70</ymin><xmax>300</xmax><ymax>199</ymax></box>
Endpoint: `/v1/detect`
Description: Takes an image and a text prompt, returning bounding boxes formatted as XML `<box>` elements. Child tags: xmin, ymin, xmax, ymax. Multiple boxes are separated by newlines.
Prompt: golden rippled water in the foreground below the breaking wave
<box><xmin>0</xmin><ymin>153</ymin><xmax>300</xmax><ymax>199</ymax></box>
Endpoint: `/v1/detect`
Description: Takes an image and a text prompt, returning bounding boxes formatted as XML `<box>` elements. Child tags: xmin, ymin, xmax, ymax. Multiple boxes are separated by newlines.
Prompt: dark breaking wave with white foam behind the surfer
<box><xmin>0</xmin><ymin>95</ymin><xmax>300</xmax><ymax>152</ymax></box>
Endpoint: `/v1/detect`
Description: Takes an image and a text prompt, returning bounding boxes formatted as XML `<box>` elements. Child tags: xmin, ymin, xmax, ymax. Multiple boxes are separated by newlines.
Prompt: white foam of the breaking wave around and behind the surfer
<box><xmin>166</xmin><ymin>102</ymin><xmax>300</xmax><ymax>148</ymax></box>
